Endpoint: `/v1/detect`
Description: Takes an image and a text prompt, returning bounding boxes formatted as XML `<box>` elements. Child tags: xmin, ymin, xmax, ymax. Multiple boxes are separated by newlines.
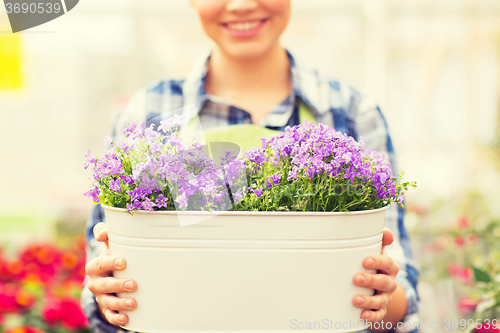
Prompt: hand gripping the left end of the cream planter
<box><xmin>85</xmin><ymin>222</ymin><xmax>137</xmax><ymax>326</ymax></box>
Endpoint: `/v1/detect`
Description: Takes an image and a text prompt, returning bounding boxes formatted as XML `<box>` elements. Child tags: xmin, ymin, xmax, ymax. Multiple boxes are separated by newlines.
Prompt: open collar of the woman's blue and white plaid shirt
<box><xmin>182</xmin><ymin>48</ymin><xmax>330</xmax><ymax>123</ymax></box>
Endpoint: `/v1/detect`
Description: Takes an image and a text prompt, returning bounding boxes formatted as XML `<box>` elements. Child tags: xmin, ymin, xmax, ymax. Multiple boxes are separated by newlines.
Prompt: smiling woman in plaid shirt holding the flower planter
<box><xmin>82</xmin><ymin>0</ymin><xmax>419</xmax><ymax>332</ymax></box>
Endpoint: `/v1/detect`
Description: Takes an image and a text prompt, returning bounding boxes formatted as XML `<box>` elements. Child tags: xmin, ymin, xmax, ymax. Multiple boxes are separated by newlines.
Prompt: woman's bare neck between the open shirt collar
<box><xmin>205</xmin><ymin>45</ymin><xmax>292</xmax><ymax>123</ymax></box>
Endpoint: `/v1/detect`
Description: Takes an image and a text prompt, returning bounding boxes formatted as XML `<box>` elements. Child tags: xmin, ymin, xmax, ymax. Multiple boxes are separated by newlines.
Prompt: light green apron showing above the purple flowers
<box><xmin>180</xmin><ymin>100</ymin><xmax>316</xmax><ymax>150</ymax></box>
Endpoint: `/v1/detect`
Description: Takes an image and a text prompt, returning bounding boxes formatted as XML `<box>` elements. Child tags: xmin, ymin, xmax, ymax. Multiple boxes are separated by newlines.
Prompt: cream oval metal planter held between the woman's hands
<box><xmin>103</xmin><ymin>206</ymin><xmax>387</xmax><ymax>333</ymax></box>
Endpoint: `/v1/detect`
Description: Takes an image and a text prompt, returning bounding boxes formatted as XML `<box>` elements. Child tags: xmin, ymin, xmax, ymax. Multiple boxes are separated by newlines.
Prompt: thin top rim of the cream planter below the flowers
<box><xmin>100</xmin><ymin>203</ymin><xmax>391</xmax><ymax>216</ymax></box>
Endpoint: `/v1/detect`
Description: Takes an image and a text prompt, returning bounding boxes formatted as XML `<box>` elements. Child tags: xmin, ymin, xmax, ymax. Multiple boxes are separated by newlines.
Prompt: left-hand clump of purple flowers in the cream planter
<box><xmin>85</xmin><ymin>116</ymin><xmax>244</xmax><ymax>212</ymax></box>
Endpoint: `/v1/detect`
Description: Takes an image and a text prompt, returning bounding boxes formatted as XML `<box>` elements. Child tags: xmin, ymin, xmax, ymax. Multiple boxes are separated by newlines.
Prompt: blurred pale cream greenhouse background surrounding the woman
<box><xmin>0</xmin><ymin>0</ymin><xmax>500</xmax><ymax>332</ymax></box>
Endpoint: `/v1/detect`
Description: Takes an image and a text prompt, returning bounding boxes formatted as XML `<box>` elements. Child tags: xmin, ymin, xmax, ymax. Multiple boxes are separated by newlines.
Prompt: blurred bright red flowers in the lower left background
<box><xmin>0</xmin><ymin>237</ymin><xmax>89</xmax><ymax>333</ymax></box>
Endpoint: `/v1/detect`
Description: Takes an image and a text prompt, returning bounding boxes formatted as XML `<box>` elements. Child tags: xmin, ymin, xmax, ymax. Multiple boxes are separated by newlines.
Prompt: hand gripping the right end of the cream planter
<box><xmin>352</xmin><ymin>229</ymin><xmax>399</xmax><ymax>322</ymax></box>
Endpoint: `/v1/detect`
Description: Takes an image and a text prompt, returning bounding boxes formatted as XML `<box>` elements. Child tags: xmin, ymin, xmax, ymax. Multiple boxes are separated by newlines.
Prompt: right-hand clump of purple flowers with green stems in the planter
<box><xmin>237</xmin><ymin>121</ymin><xmax>415</xmax><ymax>212</ymax></box>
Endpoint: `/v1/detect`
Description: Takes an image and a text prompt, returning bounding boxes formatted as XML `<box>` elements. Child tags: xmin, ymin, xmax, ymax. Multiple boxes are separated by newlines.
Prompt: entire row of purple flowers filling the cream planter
<box><xmin>85</xmin><ymin>116</ymin><xmax>415</xmax><ymax>213</ymax></box>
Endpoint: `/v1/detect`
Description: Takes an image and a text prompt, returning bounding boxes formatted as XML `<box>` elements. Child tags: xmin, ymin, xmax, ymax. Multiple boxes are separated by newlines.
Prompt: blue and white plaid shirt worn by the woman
<box><xmin>81</xmin><ymin>50</ymin><xmax>420</xmax><ymax>333</ymax></box>
